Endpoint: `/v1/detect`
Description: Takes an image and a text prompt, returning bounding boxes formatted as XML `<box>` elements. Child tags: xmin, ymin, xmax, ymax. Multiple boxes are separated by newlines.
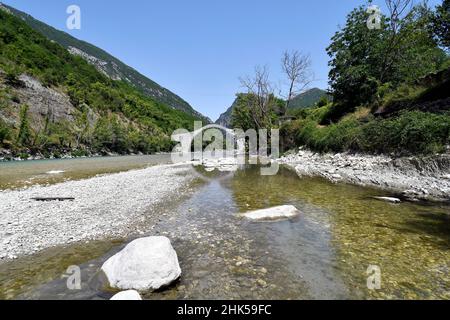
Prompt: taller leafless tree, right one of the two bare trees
<box><xmin>281</xmin><ymin>51</ymin><xmax>313</xmax><ymax>114</ymax></box>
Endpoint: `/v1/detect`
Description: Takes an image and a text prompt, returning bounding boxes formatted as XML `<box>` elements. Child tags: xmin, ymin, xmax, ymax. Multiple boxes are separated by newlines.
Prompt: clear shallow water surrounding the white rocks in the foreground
<box><xmin>0</xmin><ymin>159</ymin><xmax>450</xmax><ymax>299</ymax></box>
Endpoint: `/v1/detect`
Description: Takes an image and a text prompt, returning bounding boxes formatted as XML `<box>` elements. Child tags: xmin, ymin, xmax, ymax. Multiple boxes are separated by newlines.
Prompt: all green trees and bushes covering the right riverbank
<box><xmin>232</xmin><ymin>0</ymin><xmax>450</xmax><ymax>155</ymax></box>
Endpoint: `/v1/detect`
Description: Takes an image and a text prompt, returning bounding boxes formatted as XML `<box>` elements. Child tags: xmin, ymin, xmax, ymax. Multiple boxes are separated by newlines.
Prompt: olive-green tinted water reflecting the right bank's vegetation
<box><xmin>229</xmin><ymin>166</ymin><xmax>450</xmax><ymax>299</ymax></box>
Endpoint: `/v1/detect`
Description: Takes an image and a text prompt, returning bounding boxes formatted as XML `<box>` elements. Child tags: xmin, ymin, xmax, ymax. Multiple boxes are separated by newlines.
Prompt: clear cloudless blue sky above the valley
<box><xmin>0</xmin><ymin>0</ymin><xmax>440</xmax><ymax>120</ymax></box>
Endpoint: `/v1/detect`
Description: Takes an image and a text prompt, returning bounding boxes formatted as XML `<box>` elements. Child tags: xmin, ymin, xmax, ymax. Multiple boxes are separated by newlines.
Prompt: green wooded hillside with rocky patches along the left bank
<box><xmin>0</xmin><ymin>10</ymin><xmax>197</xmax><ymax>156</ymax></box>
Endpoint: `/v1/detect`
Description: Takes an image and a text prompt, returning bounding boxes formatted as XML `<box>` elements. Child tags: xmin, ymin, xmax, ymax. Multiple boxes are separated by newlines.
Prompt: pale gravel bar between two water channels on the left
<box><xmin>0</xmin><ymin>165</ymin><xmax>192</xmax><ymax>261</ymax></box>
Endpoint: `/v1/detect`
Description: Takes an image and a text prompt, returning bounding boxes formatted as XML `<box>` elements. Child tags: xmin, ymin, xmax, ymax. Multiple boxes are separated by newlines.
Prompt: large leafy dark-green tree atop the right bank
<box><xmin>327</xmin><ymin>0</ymin><xmax>445</xmax><ymax>116</ymax></box>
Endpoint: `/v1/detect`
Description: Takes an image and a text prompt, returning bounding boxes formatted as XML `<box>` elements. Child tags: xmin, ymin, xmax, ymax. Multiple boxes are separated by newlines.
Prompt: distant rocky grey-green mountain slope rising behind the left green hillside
<box><xmin>0</xmin><ymin>3</ymin><xmax>210</xmax><ymax>121</ymax></box>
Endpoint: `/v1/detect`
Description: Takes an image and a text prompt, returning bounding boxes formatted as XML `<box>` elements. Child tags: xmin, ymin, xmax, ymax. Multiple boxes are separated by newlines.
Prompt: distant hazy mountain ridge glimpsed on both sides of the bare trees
<box><xmin>215</xmin><ymin>88</ymin><xmax>327</xmax><ymax>128</ymax></box>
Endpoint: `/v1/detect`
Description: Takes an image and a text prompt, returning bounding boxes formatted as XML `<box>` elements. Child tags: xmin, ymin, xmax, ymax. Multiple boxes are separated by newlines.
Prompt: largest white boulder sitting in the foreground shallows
<box><xmin>102</xmin><ymin>237</ymin><xmax>181</xmax><ymax>291</ymax></box>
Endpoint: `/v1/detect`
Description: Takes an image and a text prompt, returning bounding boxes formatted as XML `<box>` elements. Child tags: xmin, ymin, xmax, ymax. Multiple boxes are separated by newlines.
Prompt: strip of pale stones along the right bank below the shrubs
<box><xmin>278</xmin><ymin>150</ymin><xmax>450</xmax><ymax>201</ymax></box>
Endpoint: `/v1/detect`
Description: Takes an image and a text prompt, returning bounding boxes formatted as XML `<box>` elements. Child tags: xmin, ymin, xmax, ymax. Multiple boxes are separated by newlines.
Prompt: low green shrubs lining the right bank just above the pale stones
<box><xmin>281</xmin><ymin>111</ymin><xmax>450</xmax><ymax>155</ymax></box>
